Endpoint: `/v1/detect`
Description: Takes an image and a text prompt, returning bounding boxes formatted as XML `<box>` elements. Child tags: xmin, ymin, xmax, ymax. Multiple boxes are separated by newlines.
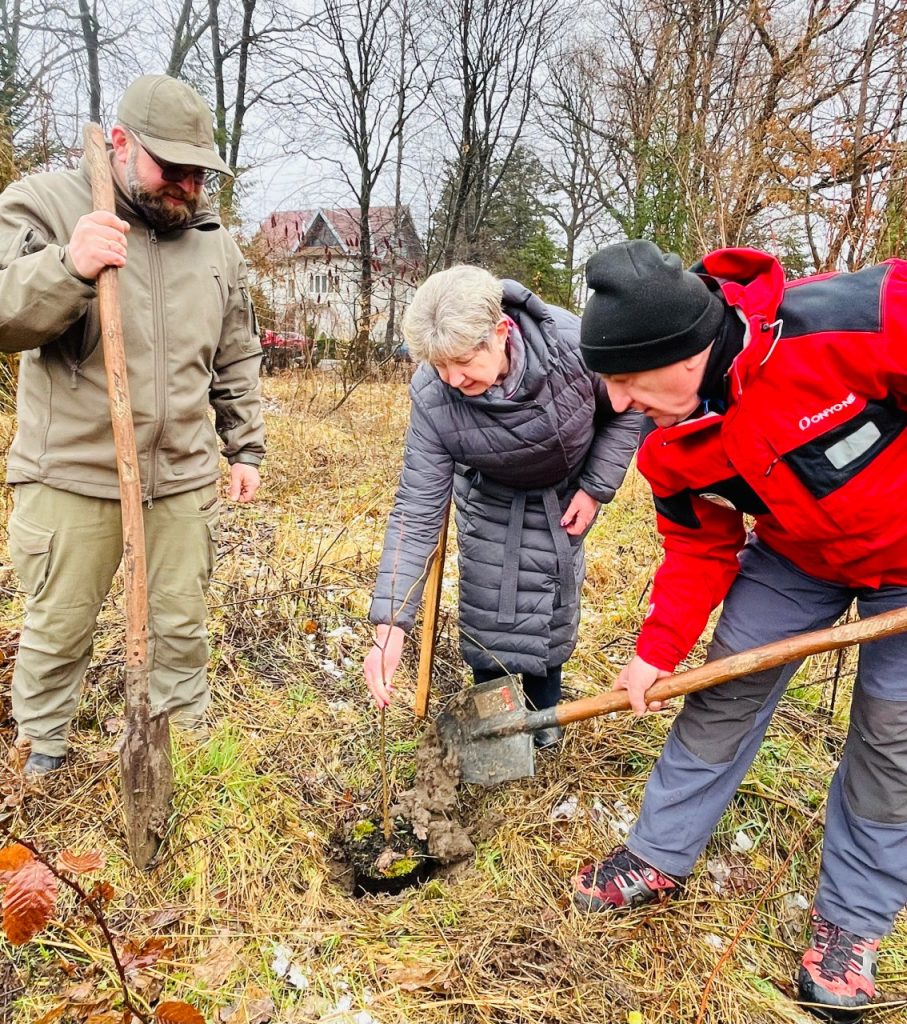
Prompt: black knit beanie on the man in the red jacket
<box><xmin>579</xmin><ymin>239</ymin><xmax>726</xmax><ymax>374</ymax></box>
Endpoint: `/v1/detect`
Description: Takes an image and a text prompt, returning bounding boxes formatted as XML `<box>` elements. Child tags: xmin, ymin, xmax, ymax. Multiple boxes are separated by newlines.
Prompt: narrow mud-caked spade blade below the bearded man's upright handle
<box><xmin>120</xmin><ymin>667</ymin><xmax>173</xmax><ymax>869</ymax></box>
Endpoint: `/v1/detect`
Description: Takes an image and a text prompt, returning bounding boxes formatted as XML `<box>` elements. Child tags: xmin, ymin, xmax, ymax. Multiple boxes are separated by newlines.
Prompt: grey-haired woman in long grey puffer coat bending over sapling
<box><xmin>364</xmin><ymin>266</ymin><xmax>641</xmax><ymax>745</ymax></box>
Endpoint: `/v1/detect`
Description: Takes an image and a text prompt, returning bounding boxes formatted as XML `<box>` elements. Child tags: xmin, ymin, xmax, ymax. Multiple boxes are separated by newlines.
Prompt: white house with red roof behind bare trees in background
<box><xmin>255</xmin><ymin>206</ymin><xmax>425</xmax><ymax>356</ymax></box>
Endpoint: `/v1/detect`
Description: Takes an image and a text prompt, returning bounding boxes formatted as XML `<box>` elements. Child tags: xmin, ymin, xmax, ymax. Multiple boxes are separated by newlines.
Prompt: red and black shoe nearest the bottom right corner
<box><xmin>800</xmin><ymin>910</ymin><xmax>878</xmax><ymax>1024</ymax></box>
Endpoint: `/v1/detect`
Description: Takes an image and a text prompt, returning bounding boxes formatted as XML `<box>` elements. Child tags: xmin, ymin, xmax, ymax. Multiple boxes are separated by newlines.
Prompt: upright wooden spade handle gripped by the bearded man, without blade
<box><xmin>82</xmin><ymin>124</ymin><xmax>148</xmax><ymax>671</ymax></box>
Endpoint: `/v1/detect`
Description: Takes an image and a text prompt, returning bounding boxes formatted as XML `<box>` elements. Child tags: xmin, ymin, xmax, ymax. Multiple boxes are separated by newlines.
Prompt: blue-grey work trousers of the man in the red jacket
<box><xmin>628</xmin><ymin>540</ymin><xmax>907</xmax><ymax>938</ymax></box>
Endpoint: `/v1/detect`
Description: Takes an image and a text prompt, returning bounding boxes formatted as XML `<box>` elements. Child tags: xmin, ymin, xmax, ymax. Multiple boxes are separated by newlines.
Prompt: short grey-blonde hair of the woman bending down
<box><xmin>403</xmin><ymin>264</ymin><xmax>504</xmax><ymax>364</ymax></box>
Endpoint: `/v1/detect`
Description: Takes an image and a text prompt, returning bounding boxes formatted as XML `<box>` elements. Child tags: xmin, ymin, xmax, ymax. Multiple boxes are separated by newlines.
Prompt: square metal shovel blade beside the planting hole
<box><xmin>436</xmin><ymin>676</ymin><xmax>535</xmax><ymax>785</ymax></box>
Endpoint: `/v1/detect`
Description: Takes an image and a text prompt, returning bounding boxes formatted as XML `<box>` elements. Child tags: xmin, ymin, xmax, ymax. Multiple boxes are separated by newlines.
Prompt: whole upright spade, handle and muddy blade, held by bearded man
<box><xmin>83</xmin><ymin>124</ymin><xmax>173</xmax><ymax>868</ymax></box>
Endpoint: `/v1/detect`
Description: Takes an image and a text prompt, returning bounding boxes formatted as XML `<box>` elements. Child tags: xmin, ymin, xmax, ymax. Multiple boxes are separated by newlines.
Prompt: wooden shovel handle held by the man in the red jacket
<box><xmin>557</xmin><ymin>608</ymin><xmax>907</xmax><ymax>725</ymax></box>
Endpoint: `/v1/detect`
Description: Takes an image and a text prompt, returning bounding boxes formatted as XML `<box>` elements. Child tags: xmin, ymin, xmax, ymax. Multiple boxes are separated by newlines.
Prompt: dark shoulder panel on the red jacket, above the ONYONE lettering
<box><xmin>778</xmin><ymin>263</ymin><xmax>891</xmax><ymax>338</ymax></box>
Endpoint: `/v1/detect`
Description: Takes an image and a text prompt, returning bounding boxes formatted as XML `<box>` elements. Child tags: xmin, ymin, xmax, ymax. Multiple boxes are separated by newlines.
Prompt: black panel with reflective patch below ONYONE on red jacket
<box><xmin>784</xmin><ymin>401</ymin><xmax>907</xmax><ymax>498</ymax></box>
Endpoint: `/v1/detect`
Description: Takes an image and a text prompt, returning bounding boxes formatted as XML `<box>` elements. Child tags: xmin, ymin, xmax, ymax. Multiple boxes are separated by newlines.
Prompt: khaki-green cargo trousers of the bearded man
<box><xmin>9</xmin><ymin>483</ymin><xmax>220</xmax><ymax>757</ymax></box>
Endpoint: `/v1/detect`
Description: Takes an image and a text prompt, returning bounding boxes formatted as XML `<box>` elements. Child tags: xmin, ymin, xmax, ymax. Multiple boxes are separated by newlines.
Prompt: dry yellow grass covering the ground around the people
<box><xmin>0</xmin><ymin>378</ymin><xmax>907</xmax><ymax>1024</ymax></box>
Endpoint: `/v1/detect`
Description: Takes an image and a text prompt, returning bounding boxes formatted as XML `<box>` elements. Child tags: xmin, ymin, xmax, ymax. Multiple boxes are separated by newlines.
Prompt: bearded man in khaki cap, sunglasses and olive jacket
<box><xmin>0</xmin><ymin>75</ymin><xmax>264</xmax><ymax>774</ymax></box>
